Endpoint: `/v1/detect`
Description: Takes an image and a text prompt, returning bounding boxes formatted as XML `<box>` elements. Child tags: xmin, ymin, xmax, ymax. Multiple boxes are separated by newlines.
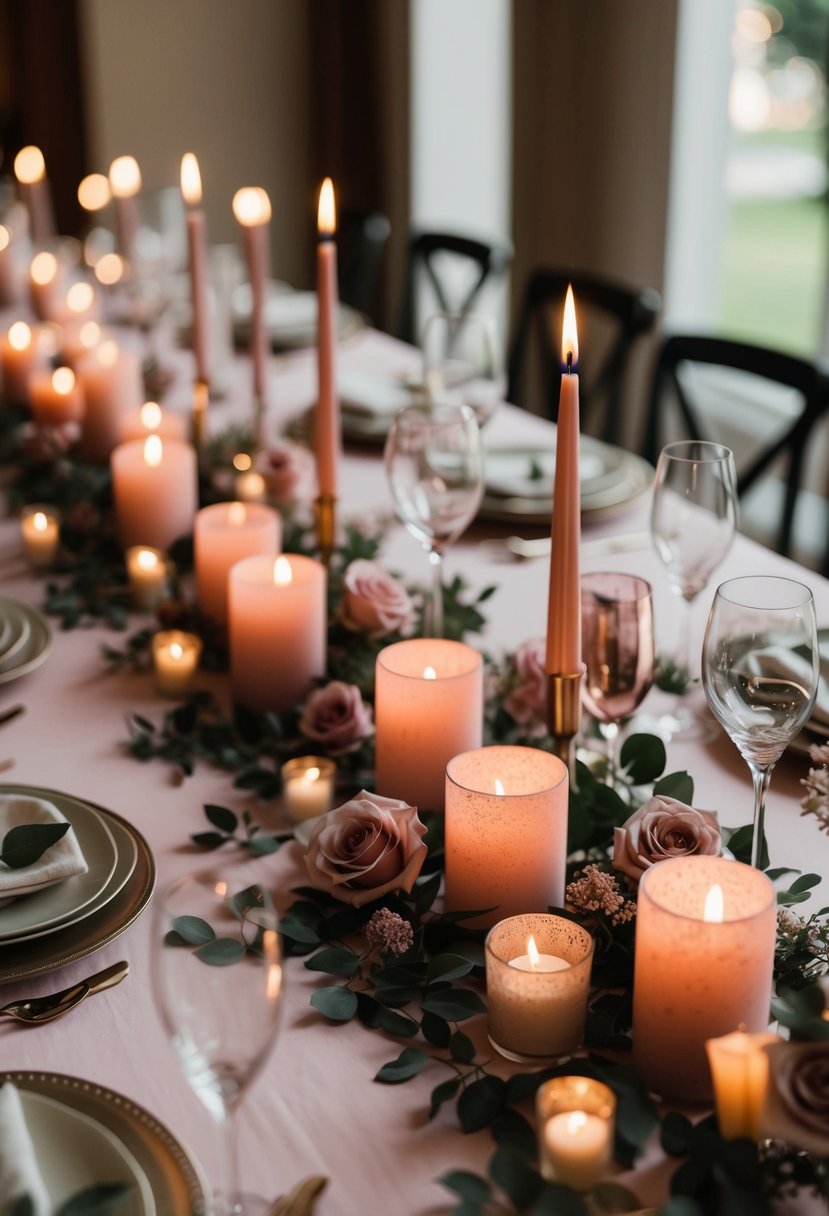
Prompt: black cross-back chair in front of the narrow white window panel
<box><xmin>397</xmin><ymin>232</ymin><xmax>513</xmax><ymax>345</ymax></box>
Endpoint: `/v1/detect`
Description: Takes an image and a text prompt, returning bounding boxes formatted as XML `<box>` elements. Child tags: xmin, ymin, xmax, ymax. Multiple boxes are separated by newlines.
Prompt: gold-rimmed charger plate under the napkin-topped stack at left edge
<box><xmin>0</xmin><ymin>786</ymin><xmax>156</xmax><ymax>984</ymax></box>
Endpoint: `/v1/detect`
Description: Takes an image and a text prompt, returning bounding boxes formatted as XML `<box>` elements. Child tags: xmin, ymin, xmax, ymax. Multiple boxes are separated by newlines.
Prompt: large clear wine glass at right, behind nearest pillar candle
<box><xmin>703</xmin><ymin>576</ymin><xmax>820</xmax><ymax>866</ymax></box>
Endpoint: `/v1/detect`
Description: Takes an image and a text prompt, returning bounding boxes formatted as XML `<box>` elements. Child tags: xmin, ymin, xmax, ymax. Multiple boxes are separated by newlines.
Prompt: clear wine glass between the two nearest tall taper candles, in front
<box><xmin>385</xmin><ymin>401</ymin><xmax>484</xmax><ymax>637</ymax></box>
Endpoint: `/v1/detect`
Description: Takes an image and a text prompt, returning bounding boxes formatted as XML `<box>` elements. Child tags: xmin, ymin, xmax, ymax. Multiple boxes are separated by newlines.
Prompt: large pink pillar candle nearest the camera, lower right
<box><xmin>633</xmin><ymin>856</ymin><xmax>777</xmax><ymax>1102</ymax></box>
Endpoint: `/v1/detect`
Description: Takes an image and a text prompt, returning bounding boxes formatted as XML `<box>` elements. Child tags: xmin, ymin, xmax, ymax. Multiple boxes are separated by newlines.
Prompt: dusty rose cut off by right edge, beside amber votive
<box><xmin>762</xmin><ymin>1040</ymin><xmax>829</xmax><ymax>1156</ymax></box>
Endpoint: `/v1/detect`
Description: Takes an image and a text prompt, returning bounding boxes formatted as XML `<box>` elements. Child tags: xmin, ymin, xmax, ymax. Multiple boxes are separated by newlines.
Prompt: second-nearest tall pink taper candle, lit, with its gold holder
<box><xmin>314</xmin><ymin>178</ymin><xmax>342</xmax><ymax>565</ymax></box>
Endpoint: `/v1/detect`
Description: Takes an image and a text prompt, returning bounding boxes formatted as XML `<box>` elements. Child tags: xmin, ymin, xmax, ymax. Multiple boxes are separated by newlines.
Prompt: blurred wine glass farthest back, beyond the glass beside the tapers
<box><xmin>421</xmin><ymin>313</ymin><xmax>507</xmax><ymax>426</ymax></box>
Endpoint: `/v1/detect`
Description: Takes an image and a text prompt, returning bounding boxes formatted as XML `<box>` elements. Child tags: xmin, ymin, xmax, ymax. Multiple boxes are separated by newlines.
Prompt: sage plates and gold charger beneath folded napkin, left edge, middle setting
<box><xmin>0</xmin><ymin>786</ymin><xmax>156</xmax><ymax>984</ymax></box>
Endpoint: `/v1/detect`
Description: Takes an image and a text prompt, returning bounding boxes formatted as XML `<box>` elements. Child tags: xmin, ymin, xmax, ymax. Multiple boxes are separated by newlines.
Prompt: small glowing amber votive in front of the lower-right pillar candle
<box><xmin>705</xmin><ymin>1030</ymin><xmax>782</xmax><ymax>1141</ymax></box>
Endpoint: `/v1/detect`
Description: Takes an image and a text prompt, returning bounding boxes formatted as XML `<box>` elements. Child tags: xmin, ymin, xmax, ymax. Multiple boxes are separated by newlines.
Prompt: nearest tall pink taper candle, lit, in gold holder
<box><xmin>546</xmin><ymin>287</ymin><xmax>581</xmax><ymax>781</ymax></box>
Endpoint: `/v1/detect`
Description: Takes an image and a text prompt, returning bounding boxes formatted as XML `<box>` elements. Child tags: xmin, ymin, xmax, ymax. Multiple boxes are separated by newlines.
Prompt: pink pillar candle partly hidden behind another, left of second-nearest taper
<box><xmin>193</xmin><ymin>502</ymin><xmax>282</xmax><ymax>625</ymax></box>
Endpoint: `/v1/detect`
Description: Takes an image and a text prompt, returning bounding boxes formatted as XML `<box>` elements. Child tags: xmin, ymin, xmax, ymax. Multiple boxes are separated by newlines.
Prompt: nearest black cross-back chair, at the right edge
<box><xmin>641</xmin><ymin>334</ymin><xmax>829</xmax><ymax>574</ymax></box>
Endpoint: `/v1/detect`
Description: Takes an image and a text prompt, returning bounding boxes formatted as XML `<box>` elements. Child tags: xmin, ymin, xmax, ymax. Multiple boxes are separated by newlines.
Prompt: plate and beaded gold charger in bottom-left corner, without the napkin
<box><xmin>0</xmin><ymin>1073</ymin><xmax>209</xmax><ymax>1216</ymax></box>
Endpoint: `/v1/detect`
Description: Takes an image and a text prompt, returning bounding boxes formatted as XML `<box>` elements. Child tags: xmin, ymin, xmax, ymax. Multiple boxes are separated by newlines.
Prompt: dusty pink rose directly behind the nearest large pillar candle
<box><xmin>613</xmin><ymin>795</ymin><xmax>722</xmax><ymax>883</ymax></box>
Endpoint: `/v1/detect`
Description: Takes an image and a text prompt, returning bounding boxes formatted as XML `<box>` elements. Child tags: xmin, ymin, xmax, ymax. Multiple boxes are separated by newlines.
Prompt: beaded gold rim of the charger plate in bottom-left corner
<box><xmin>0</xmin><ymin>1073</ymin><xmax>209</xmax><ymax>1216</ymax></box>
